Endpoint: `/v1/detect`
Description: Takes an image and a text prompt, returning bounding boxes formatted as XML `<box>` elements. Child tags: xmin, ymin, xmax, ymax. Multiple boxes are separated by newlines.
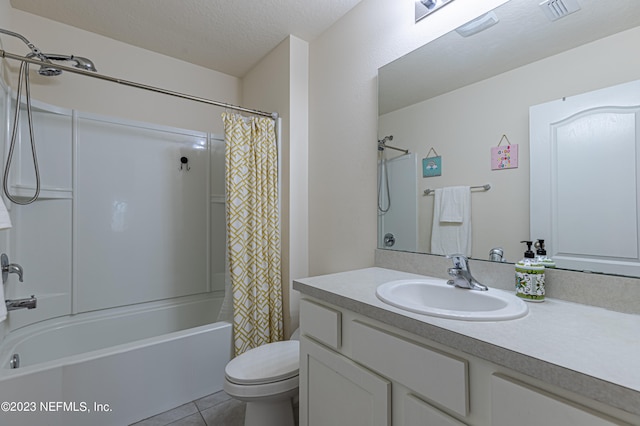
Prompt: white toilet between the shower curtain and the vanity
<box><xmin>224</xmin><ymin>333</ymin><xmax>300</xmax><ymax>426</ymax></box>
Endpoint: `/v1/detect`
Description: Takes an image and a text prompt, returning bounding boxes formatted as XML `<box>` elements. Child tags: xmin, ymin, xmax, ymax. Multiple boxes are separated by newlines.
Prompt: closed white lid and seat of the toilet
<box><xmin>224</xmin><ymin>340</ymin><xmax>300</xmax><ymax>387</ymax></box>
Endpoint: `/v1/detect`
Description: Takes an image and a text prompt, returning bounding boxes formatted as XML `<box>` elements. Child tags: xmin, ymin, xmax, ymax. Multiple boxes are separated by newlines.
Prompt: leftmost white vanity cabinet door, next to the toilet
<box><xmin>300</xmin><ymin>336</ymin><xmax>391</xmax><ymax>426</ymax></box>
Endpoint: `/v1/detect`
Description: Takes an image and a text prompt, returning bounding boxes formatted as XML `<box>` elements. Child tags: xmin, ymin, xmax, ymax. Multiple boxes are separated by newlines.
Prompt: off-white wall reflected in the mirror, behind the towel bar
<box><xmin>380</xmin><ymin>28</ymin><xmax>640</xmax><ymax>262</ymax></box>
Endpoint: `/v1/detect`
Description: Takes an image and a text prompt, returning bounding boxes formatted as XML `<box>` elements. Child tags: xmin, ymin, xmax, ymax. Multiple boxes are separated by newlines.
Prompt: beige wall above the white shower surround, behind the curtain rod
<box><xmin>0</xmin><ymin>0</ymin><xmax>241</xmax><ymax>134</ymax></box>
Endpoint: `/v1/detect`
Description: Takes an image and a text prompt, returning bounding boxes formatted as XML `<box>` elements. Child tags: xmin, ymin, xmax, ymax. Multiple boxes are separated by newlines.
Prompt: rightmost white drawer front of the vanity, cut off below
<box><xmin>491</xmin><ymin>374</ymin><xmax>620</xmax><ymax>426</ymax></box>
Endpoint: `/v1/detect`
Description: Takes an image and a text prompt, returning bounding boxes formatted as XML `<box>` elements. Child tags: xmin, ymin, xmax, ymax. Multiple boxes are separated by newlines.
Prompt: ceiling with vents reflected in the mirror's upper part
<box><xmin>378</xmin><ymin>0</ymin><xmax>640</xmax><ymax>115</ymax></box>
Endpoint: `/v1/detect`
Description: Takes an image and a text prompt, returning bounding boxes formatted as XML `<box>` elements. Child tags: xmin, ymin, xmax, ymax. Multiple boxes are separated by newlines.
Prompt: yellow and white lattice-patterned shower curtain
<box><xmin>222</xmin><ymin>113</ymin><xmax>284</xmax><ymax>355</ymax></box>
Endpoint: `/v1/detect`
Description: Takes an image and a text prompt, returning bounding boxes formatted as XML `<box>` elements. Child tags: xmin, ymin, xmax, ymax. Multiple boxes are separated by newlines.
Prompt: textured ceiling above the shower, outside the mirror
<box><xmin>11</xmin><ymin>0</ymin><xmax>360</xmax><ymax>77</ymax></box>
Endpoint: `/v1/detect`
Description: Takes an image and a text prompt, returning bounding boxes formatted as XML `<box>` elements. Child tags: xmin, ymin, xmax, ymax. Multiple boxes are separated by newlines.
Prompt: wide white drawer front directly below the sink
<box><xmin>350</xmin><ymin>321</ymin><xmax>469</xmax><ymax>416</ymax></box>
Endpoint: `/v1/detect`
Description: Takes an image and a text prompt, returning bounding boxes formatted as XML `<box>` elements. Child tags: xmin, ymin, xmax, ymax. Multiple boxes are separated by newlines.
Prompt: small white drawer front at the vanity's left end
<box><xmin>300</xmin><ymin>299</ymin><xmax>342</xmax><ymax>349</ymax></box>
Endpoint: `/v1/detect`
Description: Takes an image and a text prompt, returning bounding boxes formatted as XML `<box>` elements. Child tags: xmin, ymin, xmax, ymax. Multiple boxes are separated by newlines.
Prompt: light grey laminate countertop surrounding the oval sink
<box><xmin>293</xmin><ymin>267</ymin><xmax>640</xmax><ymax>415</ymax></box>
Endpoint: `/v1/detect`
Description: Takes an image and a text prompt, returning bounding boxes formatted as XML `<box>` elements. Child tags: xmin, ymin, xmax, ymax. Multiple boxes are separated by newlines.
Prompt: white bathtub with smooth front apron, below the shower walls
<box><xmin>0</xmin><ymin>297</ymin><xmax>231</xmax><ymax>426</ymax></box>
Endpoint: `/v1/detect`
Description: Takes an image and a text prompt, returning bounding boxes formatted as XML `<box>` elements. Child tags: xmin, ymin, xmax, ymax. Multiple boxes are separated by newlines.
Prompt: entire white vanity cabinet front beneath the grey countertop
<box><xmin>300</xmin><ymin>297</ymin><xmax>640</xmax><ymax>426</ymax></box>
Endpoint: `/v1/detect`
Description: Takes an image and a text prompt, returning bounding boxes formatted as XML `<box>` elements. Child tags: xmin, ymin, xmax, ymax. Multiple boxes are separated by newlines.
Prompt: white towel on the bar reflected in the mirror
<box><xmin>431</xmin><ymin>186</ymin><xmax>471</xmax><ymax>256</ymax></box>
